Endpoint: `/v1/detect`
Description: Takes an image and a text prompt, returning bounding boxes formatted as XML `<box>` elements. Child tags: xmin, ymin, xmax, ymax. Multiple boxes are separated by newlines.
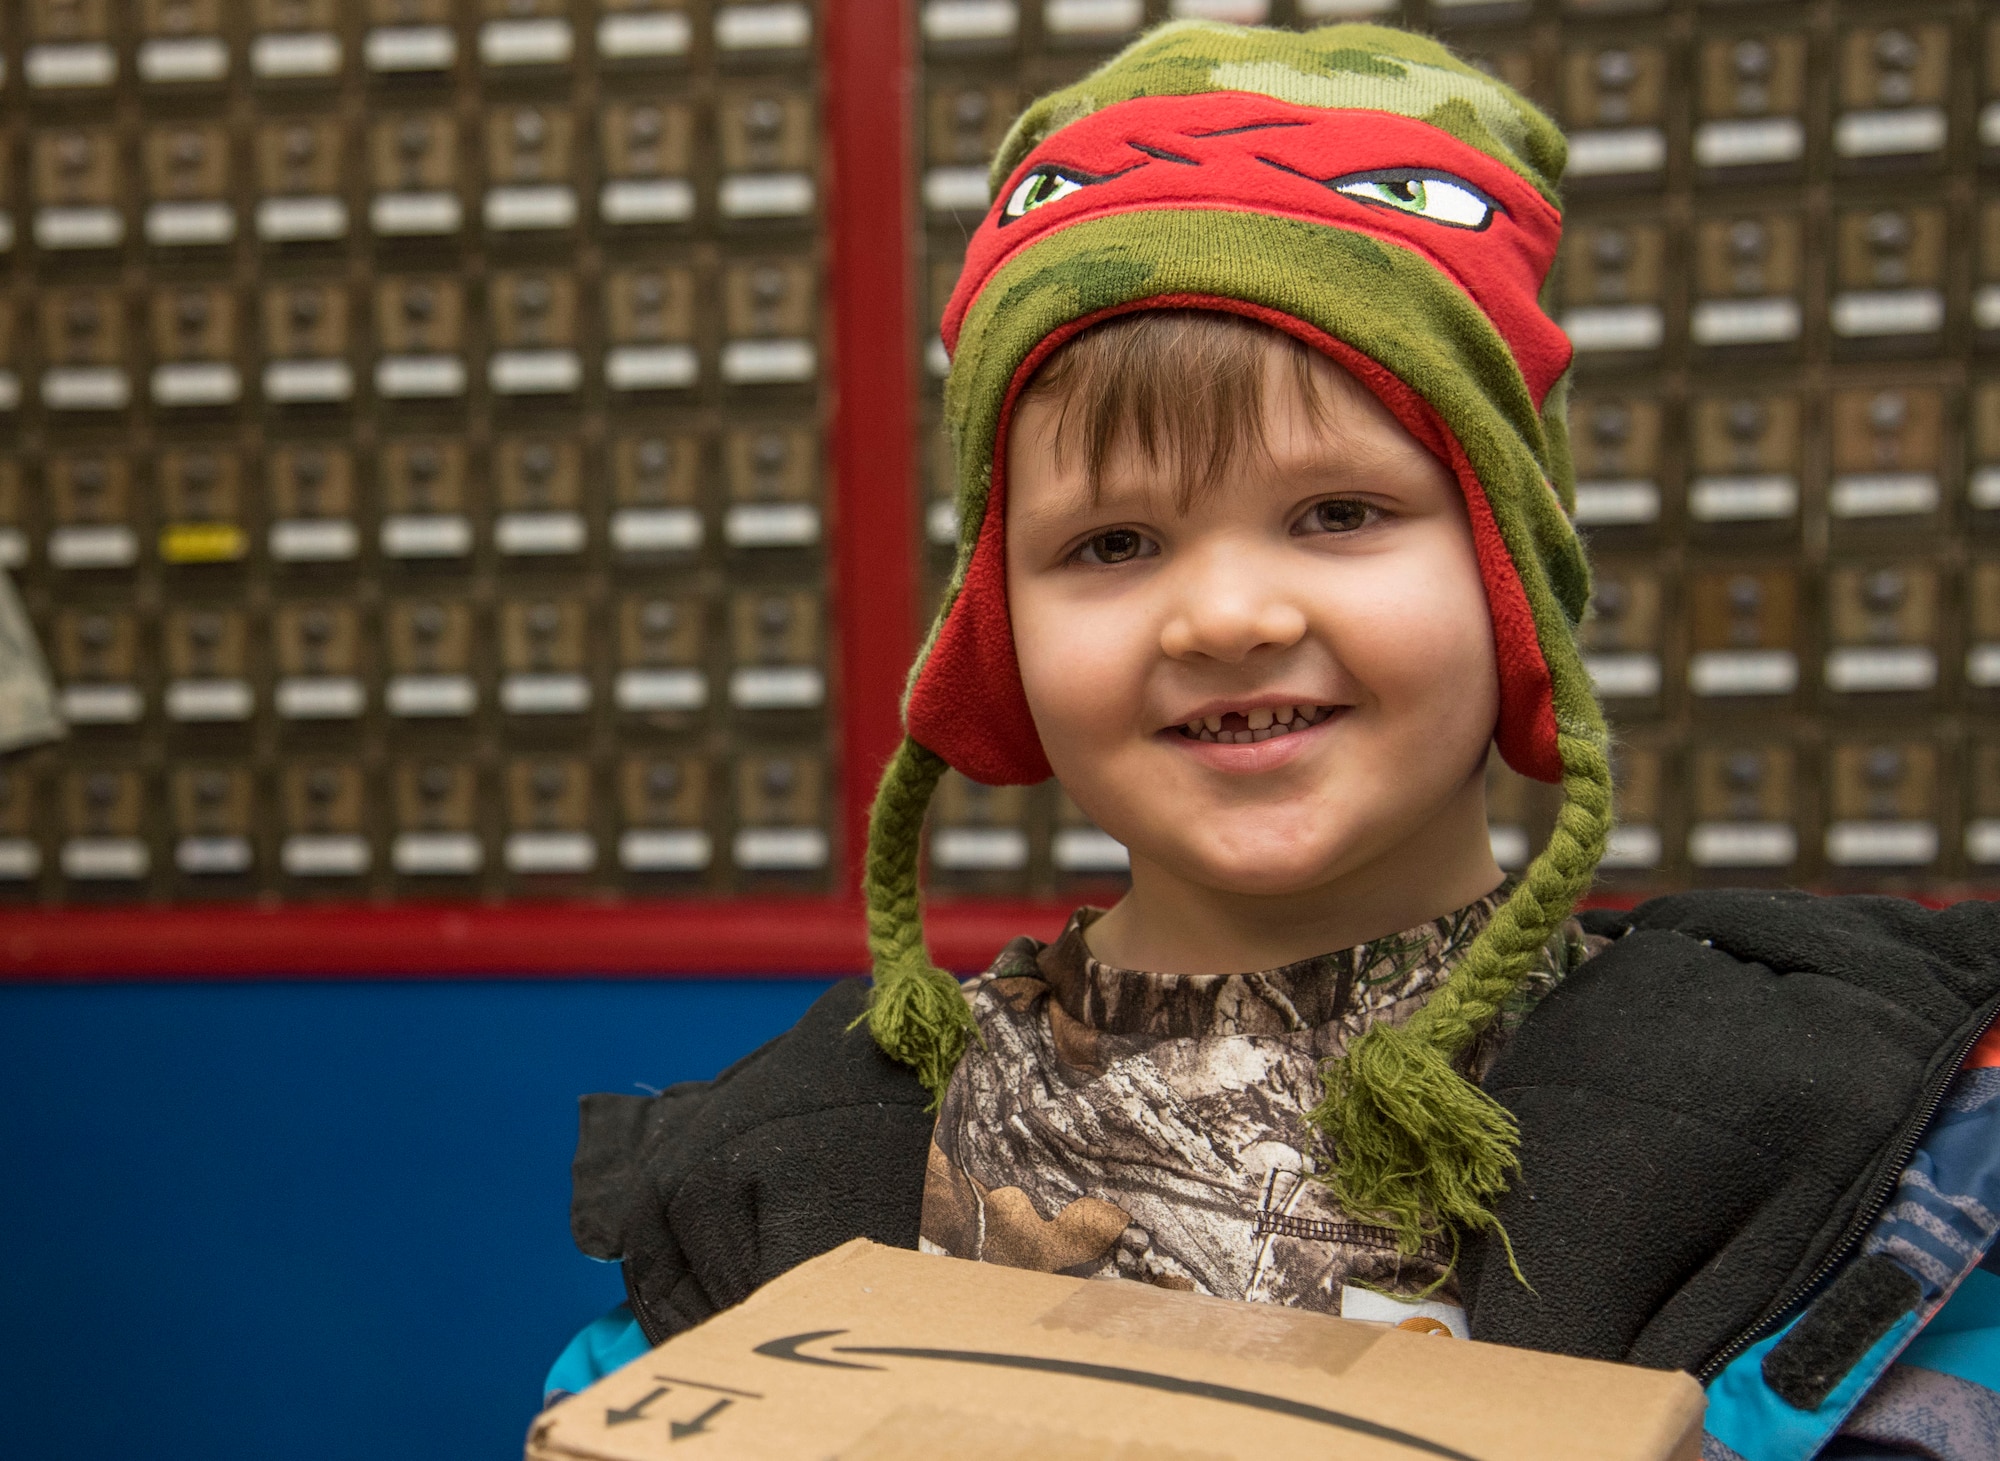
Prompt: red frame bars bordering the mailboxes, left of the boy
<box><xmin>0</xmin><ymin>0</ymin><xmax>1096</xmax><ymax>981</ymax></box>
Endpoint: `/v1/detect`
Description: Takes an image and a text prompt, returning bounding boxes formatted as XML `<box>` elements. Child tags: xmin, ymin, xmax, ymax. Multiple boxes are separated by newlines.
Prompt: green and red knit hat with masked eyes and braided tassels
<box><xmin>866</xmin><ymin>20</ymin><xmax>1610</xmax><ymax>1251</ymax></box>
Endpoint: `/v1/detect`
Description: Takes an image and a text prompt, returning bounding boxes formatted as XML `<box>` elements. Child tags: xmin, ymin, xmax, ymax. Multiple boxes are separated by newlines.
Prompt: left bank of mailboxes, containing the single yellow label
<box><xmin>0</xmin><ymin>0</ymin><xmax>828</xmax><ymax>903</ymax></box>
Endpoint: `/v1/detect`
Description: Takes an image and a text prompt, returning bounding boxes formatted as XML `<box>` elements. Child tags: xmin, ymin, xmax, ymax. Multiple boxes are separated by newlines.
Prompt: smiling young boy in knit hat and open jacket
<box><xmin>550</xmin><ymin>22</ymin><xmax>2000</xmax><ymax>1461</ymax></box>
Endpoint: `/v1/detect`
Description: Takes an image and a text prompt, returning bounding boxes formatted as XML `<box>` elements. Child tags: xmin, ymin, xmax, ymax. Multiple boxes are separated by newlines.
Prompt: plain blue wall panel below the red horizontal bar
<box><xmin>0</xmin><ymin>981</ymin><xmax>826</xmax><ymax>1461</ymax></box>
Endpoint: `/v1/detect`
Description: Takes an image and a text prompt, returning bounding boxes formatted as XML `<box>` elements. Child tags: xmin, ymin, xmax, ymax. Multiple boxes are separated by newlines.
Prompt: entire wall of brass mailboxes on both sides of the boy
<box><xmin>0</xmin><ymin>0</ymin><xmax>2000</xmax><ymax>899</ymax></box>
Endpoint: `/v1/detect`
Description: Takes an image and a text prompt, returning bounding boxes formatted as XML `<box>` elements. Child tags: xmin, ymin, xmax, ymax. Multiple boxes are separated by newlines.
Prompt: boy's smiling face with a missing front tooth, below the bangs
<box><xmin>1006</xmin><ymin>340</ymin><xmax>1500</xmax><ymax>895</ymax></box>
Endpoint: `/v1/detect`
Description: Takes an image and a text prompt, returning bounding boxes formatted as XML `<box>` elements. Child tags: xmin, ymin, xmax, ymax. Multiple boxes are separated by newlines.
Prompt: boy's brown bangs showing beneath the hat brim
<box><xmin>1024</xmin><ymin>310</ymin><xmax>1326</xmax><ymax>510</ymax></box>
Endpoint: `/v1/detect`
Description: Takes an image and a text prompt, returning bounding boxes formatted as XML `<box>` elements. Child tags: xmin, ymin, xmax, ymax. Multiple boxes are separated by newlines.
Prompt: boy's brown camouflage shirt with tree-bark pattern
<box><xmin>920</xmin><ymin>887</ymin><xmax>1600</xmax><ymax>1313</ymax></box>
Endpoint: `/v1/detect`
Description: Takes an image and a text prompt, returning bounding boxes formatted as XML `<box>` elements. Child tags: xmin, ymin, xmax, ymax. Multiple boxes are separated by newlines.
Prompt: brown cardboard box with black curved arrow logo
<box><xmin>528</xmin><ymin>1241</ymin><xmax>1702</xmax><ymax>1461</ymax></box>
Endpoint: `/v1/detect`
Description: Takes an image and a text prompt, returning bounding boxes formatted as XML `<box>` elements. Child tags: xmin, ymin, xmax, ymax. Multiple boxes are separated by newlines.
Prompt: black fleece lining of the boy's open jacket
<box><xmin>572</xmin><ymin>893</ymin><xmax>2000</xmax><ymax>1371</ymax></box>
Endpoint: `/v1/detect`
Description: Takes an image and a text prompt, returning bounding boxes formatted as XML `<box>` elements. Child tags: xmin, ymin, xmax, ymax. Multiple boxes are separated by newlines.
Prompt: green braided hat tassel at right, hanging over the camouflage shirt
<box><xmin>1312</xmin><ymin>724</ymin><xmax>1612</xmax><ymax>1283</ymax></box>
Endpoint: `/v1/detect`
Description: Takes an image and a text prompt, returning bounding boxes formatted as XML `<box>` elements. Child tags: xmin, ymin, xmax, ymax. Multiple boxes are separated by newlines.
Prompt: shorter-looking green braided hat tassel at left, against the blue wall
<box><xmin>856</xmin><ymin>739</ymin><xmax>978</xmax><ymax>1111</ymax></box>
